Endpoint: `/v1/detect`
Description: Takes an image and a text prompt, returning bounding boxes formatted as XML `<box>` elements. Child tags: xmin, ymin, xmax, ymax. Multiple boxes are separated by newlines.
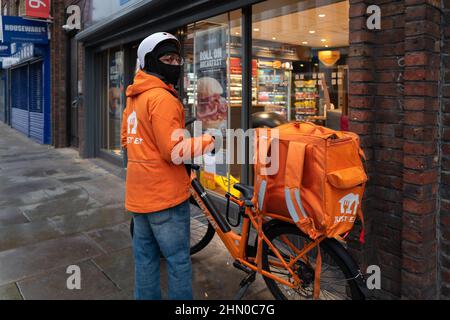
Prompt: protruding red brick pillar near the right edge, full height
<box><xmin>401</xmin><ymin>0</ymin><xmax>441</xmax><ymax>299</ymax></box>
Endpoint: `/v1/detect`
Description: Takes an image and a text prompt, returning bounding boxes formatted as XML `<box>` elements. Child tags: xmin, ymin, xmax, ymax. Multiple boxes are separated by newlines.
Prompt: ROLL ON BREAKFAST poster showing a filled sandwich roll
<box><xmin>194</xmin><ymin>27</ymin><xmax>228</xmax><ymax>132</ymax></box>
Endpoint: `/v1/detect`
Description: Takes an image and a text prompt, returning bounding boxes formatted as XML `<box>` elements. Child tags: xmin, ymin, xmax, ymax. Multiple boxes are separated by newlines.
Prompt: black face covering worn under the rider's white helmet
<box><xmin>145</xmin><ymin>41</ymin><xmax>181</xmax><ymax>86</ymax></box>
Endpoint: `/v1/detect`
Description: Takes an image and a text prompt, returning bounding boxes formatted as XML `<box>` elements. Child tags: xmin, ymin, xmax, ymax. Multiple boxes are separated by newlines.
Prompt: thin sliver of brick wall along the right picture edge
<box><xmin>439</xmin><ymin>0</ymin><xmax>450</xmax><ymax>299</ymax></box>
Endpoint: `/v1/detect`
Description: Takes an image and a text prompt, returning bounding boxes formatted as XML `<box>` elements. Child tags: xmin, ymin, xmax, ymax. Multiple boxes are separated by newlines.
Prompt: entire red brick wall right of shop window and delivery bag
<box><xmin>349</xmin><ymin>0</ymin><xmax>450</xmax><ymax>299</ymax></box>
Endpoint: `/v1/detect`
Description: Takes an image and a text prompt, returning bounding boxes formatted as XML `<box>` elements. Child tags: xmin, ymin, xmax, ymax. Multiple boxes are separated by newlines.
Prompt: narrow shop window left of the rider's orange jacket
<box><xmin>101</xmin><ymin>48</ymin><xmax>125</xmax><ymax>156</ymax></box>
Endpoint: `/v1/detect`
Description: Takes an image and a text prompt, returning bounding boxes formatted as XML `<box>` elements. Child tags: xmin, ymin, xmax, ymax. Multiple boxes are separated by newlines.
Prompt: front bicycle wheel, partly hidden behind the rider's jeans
<box><xmin>130</xmin><ymin>197</ymin><xmax>216</xmax><ymax>255</ymax></box>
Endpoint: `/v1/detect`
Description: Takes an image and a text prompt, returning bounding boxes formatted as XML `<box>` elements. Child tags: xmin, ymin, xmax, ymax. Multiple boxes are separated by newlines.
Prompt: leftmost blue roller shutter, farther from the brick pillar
<box><xmin>11</xmin><ymin>66</ymin><xmax>29</xmax><ymax>136</ymax></box>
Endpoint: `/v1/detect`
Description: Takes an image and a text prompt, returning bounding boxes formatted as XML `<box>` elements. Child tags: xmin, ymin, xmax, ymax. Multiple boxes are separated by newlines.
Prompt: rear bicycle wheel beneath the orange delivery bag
<box><xmin>262</xmin><ymin>224</ymin><xmax>365</xmax><ymax>300</ymax></box>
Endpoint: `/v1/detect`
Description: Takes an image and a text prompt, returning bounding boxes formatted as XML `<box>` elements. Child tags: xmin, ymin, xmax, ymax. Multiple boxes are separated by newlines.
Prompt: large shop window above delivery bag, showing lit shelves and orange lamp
<box><xmin>252</xmin><ymin>0</ymin><xmax>349</xmax><ymax>129</ymax></box>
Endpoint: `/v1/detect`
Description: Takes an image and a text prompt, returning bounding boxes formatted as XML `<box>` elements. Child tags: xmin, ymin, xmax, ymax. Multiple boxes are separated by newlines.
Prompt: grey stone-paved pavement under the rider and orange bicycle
<box><xmin>0</xmin><ymin>123</ymin><xmax>272</xmax><ymax>300</ymax></box>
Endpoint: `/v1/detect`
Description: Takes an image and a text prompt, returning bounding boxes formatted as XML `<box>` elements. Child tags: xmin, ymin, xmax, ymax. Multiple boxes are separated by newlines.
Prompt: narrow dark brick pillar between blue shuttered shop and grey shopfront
<box><xmin>50</xmin><ymin>0</ymin><xmax>69</xmax><ymax>148</ymax></box>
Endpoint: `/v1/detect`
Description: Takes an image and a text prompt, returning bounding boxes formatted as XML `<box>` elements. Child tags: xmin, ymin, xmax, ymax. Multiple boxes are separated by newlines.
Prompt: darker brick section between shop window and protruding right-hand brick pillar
<box><xmin>349</xmin><ymin>0</ymin><xmax>404</xmax><ymax>298</ymax></box>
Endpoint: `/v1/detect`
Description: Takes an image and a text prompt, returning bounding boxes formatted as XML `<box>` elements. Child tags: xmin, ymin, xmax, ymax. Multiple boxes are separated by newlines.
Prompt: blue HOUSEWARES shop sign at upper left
<box><xmin>2</xmin><ymin>16</ymin><xmax>48</xmax><ymax>44</ymax></box>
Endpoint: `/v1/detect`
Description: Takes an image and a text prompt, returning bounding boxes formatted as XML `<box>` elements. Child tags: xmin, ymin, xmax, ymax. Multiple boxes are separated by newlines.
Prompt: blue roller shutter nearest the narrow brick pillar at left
<box><xmin>29</xmin><ymin>62</ymin><xmax>44</xmax><ymax>143</ymax></box>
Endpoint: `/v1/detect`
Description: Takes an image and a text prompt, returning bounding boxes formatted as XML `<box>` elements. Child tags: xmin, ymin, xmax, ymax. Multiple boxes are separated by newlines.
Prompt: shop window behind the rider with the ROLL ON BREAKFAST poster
<box><xmin>180</xmin><ymin>11</ymin><xmax>243</xmax><ymax>194</ymax></box>
